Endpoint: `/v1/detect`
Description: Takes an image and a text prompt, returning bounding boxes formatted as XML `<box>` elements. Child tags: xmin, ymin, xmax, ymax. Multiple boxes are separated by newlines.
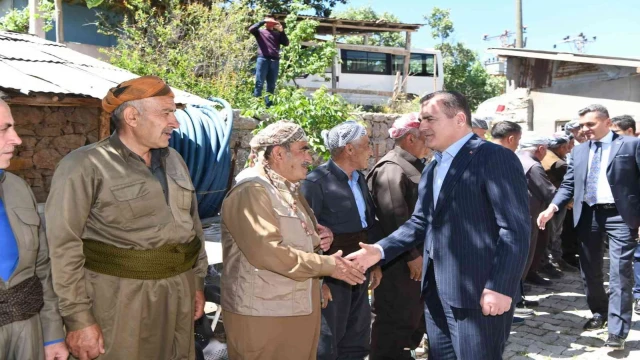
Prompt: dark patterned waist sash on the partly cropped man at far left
<box><xmin>0</xmin><ymin>276</ymin><xmax>44</xmax><ymax>326</ymax></box>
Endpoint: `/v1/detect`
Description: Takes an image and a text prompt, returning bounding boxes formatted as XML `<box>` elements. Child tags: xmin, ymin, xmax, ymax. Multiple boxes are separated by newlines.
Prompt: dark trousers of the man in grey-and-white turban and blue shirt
<box><xmin>318</xmin><ymin>274</ymin><xmax>371</xmax><ymax>360</ymax></box>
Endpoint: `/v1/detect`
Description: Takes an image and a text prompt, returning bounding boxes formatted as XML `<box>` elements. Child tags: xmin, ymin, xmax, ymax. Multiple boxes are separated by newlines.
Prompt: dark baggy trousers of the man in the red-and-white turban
<box><xmin>369</xmin><ymin>256</ymin><xmax>426</xmax><ymax>360</ymax></box>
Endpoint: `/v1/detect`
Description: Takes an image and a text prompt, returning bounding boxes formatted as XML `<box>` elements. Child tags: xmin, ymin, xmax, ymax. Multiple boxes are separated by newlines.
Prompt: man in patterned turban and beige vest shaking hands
<box><xmin>221</xmin><ymin>121</ymin><xmax>365</xmax><ymax>360</ymax></box>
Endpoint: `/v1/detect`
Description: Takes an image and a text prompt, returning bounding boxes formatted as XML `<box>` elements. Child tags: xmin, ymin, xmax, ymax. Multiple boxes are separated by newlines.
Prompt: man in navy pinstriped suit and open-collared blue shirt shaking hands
<box><xmin>347</xmin><ymin>91</ymin><xmax>530</xmax><ymax>360</ymax></box>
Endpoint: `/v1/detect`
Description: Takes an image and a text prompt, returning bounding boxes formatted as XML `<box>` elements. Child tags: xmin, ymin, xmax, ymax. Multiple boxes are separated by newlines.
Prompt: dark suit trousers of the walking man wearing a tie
<box><xmin>577</xmin><ymin>203</ymin><xmax>638</xmax><ymax>338</ymax></box>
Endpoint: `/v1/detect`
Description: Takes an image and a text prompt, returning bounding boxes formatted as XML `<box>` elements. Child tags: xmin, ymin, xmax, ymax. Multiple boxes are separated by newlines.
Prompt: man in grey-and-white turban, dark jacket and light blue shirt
<box><xmin>302</xmin><ymin>121</ymin><xmax>382</xmax><ymax>360</ymax></box>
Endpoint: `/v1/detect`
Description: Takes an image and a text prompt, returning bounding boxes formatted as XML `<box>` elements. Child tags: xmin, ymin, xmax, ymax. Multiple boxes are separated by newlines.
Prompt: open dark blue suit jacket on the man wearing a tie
<box><xmin>553</xmin><ymin>133</ymin><xmax>640</xmax><ymax>229</ymax></box>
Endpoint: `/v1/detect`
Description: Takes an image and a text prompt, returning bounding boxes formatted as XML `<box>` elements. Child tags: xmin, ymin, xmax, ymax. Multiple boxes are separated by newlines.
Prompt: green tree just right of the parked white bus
<box><xmin>425</xmin><ymin>7</ymin><xmax>505</xmax><ymax>109</ymax></box>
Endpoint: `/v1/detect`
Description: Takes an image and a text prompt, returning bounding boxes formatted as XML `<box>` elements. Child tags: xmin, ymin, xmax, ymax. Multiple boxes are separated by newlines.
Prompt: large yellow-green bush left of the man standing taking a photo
<box><xmin>106</xmin><ymin>1</ymin><xmax>255</xmax><ymax>107</ymax></box>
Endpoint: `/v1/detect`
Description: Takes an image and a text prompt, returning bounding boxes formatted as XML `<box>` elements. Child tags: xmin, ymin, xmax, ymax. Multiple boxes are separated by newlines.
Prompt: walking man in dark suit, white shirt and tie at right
<box><xmin>538</xmin><ymin>105</ymin><xmax>640</xmax><ymax>349</ymax></box>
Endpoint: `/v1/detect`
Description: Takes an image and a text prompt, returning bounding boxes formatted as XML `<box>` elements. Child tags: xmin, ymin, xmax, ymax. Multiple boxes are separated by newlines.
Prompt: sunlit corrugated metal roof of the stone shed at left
<box><xmin>0</xmin><ymin>31</ymin><xmax>211</xmax><ymax>105</ymax></box>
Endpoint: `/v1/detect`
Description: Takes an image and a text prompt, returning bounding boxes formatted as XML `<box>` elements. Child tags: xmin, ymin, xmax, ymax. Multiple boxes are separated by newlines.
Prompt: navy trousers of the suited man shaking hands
<box><xmin>424</xmin><ymin>265</ymin><xmax>514</xmax><ymax>360</ymax></box>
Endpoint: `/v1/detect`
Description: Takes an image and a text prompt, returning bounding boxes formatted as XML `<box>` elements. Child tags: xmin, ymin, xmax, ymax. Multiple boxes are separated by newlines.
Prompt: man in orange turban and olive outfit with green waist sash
<box><xmin>45</xmin><ymin>76</ymin><xmax>207</xmax><ymax>360</ymax></box>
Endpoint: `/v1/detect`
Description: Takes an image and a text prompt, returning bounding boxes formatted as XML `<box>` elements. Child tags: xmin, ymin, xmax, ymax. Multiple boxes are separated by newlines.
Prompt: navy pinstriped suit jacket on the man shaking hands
<box><xmin>378</xmin><ymin>135</ymin><xmax>530</xmax><ymax>309</ymax></box>
